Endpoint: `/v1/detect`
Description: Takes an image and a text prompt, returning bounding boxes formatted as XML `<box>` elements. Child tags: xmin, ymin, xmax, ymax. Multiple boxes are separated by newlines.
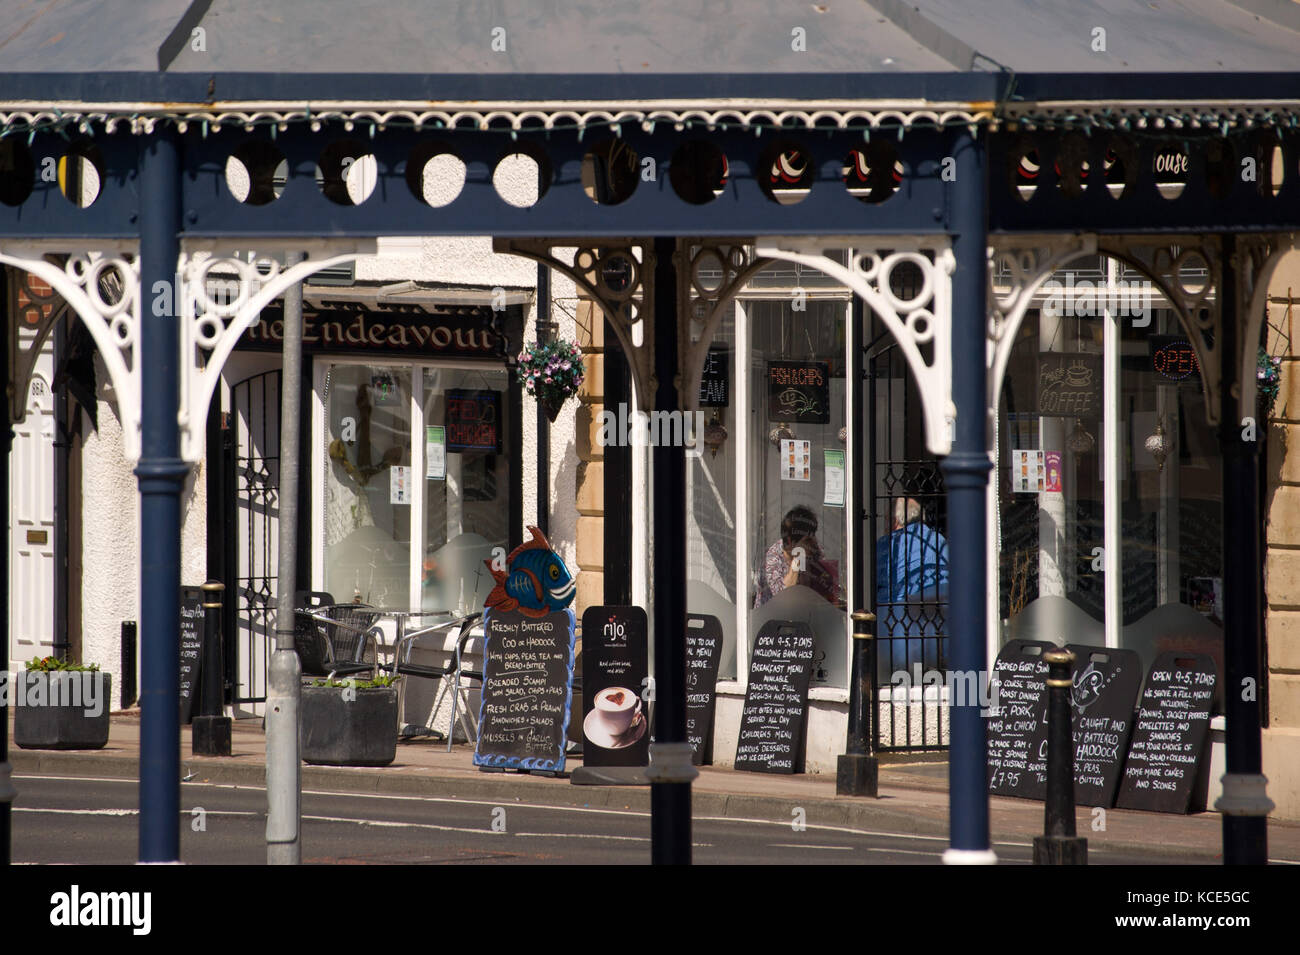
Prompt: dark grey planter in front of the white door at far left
<box><xmin>13</xmin><ymin>670</ymin><xmax>113</xmax><ymax>750</ymax></box>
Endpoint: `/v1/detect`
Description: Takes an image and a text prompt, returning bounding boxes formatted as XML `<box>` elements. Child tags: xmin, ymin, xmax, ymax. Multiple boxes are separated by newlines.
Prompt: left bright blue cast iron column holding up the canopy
<box><xmin>135</xmin><ymin>127</ymin><xmax>190</xmax><ymax>863</ymax></box>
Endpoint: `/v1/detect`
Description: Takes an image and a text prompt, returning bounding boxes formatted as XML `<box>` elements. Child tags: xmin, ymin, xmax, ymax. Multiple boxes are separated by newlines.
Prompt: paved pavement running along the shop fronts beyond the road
<box><xmin>9</xmin><ymin>712</ymin><xmax>1300</xmax><ymax>864</ymax></box>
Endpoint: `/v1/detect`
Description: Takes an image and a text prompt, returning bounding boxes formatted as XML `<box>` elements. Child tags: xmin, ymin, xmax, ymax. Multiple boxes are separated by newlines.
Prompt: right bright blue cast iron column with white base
<box><xmin>940</xmin><ymin>129</ymin><xmax>997</xmax><ymax>864</ymax></box>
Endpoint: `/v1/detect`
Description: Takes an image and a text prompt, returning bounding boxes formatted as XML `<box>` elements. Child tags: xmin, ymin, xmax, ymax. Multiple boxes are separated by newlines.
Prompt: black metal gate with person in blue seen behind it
<box><xmin>863</xmin><ymin>312</ymin><xmax>948</xmax><ymax>752</ymax></box>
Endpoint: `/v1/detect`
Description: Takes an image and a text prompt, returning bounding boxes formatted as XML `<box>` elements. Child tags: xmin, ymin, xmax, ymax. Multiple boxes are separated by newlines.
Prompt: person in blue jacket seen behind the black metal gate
<box><xmin>876</xmin><ymin>498</ymin><xmax>948</xmax><ymax>683</ymax></box>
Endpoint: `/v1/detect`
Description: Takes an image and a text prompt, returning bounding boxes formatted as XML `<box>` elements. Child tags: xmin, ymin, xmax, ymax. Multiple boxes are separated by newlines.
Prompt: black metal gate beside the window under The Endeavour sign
<box><xmin>226</xmin><ymin>369</ymin><xmax>280</xmax><ymax>704</ymax></box>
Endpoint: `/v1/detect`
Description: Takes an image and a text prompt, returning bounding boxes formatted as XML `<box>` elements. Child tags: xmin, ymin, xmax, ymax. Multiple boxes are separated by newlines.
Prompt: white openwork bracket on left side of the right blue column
<box><xmin>755</xmin><ymin>235</ymin><xmax>957</xmax><ymax>455</ymax></box>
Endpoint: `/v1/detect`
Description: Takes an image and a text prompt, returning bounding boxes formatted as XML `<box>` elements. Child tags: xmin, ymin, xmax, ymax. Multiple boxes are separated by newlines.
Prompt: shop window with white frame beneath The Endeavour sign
<box><xmin>319</xmin><ymin>360</ymin><xmax>511</xmax><ymax>613</ymax></box>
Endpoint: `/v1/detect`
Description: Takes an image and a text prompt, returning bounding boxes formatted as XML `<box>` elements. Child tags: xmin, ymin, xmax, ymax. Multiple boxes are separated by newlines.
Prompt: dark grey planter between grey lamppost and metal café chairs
<box><xmin>302</xmin><ymin>686</ymin><xmax>398</xmax><ymax>767</ymax></box>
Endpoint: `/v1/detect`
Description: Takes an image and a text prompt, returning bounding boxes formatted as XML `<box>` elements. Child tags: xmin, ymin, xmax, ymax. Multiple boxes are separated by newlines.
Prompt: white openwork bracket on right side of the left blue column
<box><xmin>176</xmin><ymin>239</ymin><xmax>376</xmax><ymax>464</ymax></box>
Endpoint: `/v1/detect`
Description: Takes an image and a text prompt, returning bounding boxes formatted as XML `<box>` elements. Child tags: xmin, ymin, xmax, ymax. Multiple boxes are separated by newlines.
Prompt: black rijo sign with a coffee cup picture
<box><xmin>582</xmin><ymin>607</ymin><xmax>650</xmax><ymax>767</ymax></box>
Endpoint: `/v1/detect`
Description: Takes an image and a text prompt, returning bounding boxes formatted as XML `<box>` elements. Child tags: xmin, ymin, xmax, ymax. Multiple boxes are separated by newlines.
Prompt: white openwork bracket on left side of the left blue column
<box><xmin>0</xmin><ymin>242</ymin><xmax>140</xmax><ymax>464</ymax></box>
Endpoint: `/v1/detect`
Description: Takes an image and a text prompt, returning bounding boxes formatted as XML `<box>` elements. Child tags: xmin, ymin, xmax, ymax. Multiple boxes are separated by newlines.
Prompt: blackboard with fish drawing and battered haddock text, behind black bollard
<box><xmin>1066</xmin><ymin>643</ymin><xmax>1141</xmax><ymax>808</ymax></box>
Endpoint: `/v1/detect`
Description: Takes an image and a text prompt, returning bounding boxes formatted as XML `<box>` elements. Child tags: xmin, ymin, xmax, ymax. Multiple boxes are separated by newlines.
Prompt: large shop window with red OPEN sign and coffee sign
<box><xmin>995</xmin><ymin>259</ymin><xmax>1223</xmax><ymax>686</ymax></box>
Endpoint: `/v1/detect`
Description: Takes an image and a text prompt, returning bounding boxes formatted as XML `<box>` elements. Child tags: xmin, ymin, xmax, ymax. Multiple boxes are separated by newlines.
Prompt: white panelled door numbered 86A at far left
<box><xmin>9</xmin><ymin>340</ymin><xmax>55</xmax><ymax>668</ymax></box>
